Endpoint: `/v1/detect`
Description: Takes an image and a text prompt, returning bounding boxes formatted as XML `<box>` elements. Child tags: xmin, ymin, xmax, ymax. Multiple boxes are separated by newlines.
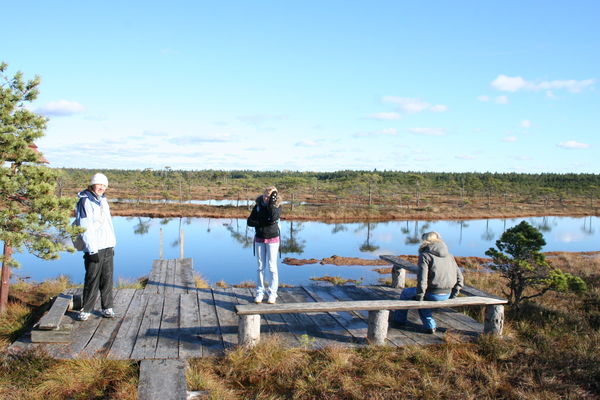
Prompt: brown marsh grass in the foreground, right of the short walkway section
<box><xmin>187</xmin><ymin>254</ymin><xmax>600</xmax><ymax>400</ymax></box>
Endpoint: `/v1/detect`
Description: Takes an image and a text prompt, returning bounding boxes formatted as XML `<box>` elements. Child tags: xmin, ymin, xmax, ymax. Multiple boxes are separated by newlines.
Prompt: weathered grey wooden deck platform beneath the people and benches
<box><xmin>11</xmin><ymin>259</ymin><xmax>483</xmax><ymax>360</ymax></box>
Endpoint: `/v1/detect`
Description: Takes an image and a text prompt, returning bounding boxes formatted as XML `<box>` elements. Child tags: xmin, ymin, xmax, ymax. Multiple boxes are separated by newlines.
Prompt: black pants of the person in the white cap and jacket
<box><xmin>83</xmin><ymin>247</ymin><xmax>115</xmax><ymax>312</ymax></box>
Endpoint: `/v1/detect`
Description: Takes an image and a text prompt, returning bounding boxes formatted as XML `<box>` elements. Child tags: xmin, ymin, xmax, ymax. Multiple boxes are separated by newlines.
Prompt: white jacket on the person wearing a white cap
<box><xmin>73</xmin><ymin>190</ymin><xmax>117</xmax><ymax>254</ymax></box>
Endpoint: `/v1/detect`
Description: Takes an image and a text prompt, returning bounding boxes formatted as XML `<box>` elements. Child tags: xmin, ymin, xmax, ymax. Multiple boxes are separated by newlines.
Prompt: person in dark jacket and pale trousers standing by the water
<box><xmin>248</xmin><ymin>186</ymin><xmax>281</xmax><ymax>304</ymax></box>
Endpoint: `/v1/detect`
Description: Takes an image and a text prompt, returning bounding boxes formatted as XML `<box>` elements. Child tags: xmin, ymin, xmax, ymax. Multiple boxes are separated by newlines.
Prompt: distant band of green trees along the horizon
<box><xmin>58</xmin><ymin>166</ymin><xmax>600</xmax><ymax>207</ymax></box>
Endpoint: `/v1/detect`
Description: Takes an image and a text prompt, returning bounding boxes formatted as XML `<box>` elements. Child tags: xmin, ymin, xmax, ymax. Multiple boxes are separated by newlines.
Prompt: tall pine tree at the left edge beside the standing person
<box><xmin>0</xmin><ymin>63</ymin><xmax>76</xmax><ymax>313</ymax></box>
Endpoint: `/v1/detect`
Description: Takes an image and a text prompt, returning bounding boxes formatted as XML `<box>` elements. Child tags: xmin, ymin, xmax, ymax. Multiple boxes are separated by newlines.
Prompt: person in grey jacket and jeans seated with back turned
<box><xmin>393</xmin><ymin>232</ymin><xmax>464</xmax><ymax>333</ymax></box>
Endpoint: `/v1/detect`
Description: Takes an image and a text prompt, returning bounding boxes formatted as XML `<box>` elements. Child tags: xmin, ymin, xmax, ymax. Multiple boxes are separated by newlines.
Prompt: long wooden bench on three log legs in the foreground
<box><xmin>235</xmin><ymin>296</ymin><xmax>507</xmax><ymax>346</ymax></box>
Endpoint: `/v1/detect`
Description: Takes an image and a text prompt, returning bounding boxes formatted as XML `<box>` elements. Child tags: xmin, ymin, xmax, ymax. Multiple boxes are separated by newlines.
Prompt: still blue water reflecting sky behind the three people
<box><xmin>13</xmin><ymin>217</ymin><xmax>600</xmax><ymax>285</ymax></box>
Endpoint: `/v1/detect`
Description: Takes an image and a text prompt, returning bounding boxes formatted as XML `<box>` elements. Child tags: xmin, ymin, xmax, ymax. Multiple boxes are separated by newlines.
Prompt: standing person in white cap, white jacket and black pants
<box><xmin>74</xmin><ymin>173</ymin><xmax>116</xmax><ymax>321</ymax></box>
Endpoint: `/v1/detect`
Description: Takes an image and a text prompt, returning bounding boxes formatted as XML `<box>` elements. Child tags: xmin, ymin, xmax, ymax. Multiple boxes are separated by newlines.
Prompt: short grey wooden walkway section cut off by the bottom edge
<box><xmin>138</xmin><ymin>360</ymin><xmax>187</xmax><ymax>400</ymax></box>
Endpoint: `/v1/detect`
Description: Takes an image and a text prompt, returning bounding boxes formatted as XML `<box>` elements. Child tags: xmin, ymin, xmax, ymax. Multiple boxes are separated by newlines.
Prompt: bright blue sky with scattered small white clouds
<box><xmin>0</xmin><ymin>0</ymin><xmax>600</xmax><ymax>173</ymax></box>
